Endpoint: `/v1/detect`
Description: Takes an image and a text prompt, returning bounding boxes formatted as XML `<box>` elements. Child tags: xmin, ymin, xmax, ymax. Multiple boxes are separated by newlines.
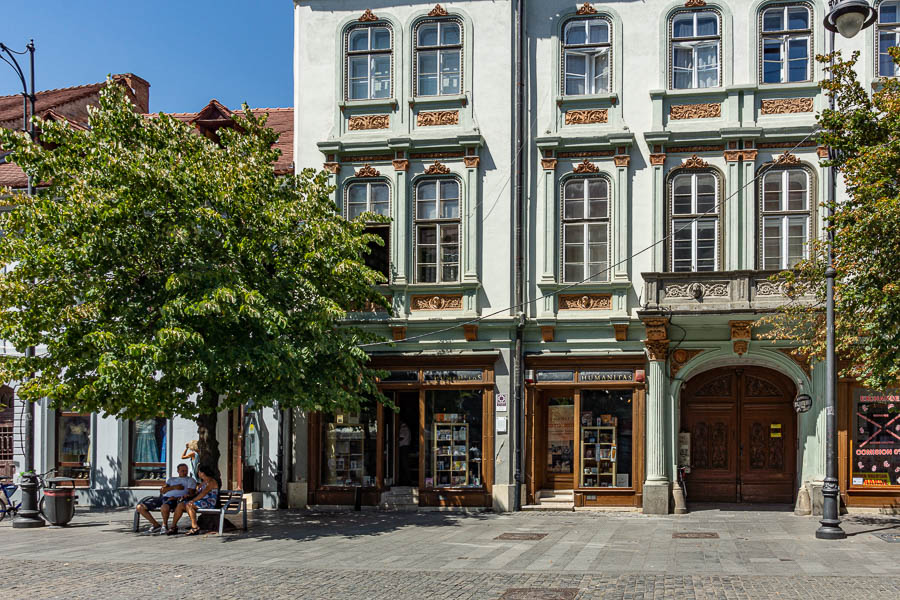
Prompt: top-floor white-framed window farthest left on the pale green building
<box><xmin>347</xmin><ymin>25</ymin><xmax>392</xmax><ymax>100</ymax></box>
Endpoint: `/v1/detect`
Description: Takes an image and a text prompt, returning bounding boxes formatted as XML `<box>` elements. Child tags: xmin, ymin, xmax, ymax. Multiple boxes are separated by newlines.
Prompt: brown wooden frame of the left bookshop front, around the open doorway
<box><xmin>308</xmin><ymin>353</ymin><xmax>499</xmax><ymax>507</ymax></box>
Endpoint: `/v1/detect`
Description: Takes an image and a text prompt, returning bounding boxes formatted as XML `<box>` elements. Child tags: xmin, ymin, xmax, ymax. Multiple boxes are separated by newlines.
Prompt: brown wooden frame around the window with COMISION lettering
<box><xmin>837</xmin><ymin>378</ymin><xmax>900</xmax><ymax>510</ymax></box>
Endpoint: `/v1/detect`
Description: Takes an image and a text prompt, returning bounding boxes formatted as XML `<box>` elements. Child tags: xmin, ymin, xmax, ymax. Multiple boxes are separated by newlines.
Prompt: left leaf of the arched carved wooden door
<box><xmin>681</xmin><ymin>371</ymin><xmax>739</xmax><ymax>502</ymax></box>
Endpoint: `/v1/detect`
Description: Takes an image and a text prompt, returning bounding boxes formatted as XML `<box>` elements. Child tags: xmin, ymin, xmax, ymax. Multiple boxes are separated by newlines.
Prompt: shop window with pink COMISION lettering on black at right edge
<box><xmin>851</xmin><ymin>388</ymin><xmax>900</xmax><ymax>487</ymax></box>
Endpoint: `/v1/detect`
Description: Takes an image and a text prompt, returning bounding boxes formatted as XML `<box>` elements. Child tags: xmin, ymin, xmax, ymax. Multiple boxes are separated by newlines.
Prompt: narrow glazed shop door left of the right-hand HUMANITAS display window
<box><xmin>541</xmin><ymin>392</ymin><xmax>575</xmax><ymax>490</ymax></box>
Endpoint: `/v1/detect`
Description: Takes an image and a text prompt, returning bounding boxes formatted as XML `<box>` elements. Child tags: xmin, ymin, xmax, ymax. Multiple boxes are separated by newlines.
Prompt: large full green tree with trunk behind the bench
<box><xmin>0</xmin><ymin>81</ymin><xmax>386</xmax><ymax>465</ymax></box>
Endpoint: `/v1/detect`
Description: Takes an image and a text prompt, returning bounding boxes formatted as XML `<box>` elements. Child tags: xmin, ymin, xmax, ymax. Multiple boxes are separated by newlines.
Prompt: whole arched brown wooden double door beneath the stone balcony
<box><xmin>681</xmin><ymin>367</ymin><xmax>797</xmax><ymax>503</ymax></box>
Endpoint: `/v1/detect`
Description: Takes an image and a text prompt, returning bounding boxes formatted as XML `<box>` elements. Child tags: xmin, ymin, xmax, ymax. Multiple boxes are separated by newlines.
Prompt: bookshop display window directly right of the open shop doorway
<box><xmin>425</xmin><ymin>390</ymin><xmax>483</xmax><ymax>488</ymax></box>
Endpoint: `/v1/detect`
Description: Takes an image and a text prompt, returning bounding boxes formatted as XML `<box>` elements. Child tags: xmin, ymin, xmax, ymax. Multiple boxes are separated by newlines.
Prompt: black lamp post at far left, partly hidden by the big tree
<box><xmin>0</xmin><ymin>40</ymin><xmax>45</xmax><ymax>528</ymax></box>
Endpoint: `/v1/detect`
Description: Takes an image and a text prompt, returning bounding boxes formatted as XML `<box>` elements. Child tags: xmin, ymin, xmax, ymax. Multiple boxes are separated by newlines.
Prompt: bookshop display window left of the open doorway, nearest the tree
<box><xmin>322</xmin><ymin>405</ymin><xmax>378</xmax><ymax>487</ymax></box>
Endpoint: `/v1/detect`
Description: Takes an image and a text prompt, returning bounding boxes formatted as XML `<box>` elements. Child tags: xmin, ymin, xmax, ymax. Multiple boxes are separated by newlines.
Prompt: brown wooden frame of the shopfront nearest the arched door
<box><xmin>525</xmin><ymin>355</ymin><xmax>647</xmax><ymax>507</ymax></box>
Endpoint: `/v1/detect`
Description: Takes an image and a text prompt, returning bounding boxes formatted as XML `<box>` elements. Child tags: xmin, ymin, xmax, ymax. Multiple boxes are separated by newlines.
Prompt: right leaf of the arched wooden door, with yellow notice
<box><xmin>740</xmin><ymin>369</ymin><xmax>797</xmax><ymax>503</ymax></box>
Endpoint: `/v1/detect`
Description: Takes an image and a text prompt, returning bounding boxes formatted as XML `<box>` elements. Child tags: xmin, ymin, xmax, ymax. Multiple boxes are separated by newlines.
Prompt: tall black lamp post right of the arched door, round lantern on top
<box><xmin>816</xmin><ymin>0</ymin><xmax>876</xmax><ymax>540</ymax></box>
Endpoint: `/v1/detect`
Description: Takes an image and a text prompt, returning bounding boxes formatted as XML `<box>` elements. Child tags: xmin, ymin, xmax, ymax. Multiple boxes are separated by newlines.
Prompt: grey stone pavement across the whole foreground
<box><xmin>0</xmin><ymin>507</ymin><xmax>900</xmax><ymax>600</ymax></box>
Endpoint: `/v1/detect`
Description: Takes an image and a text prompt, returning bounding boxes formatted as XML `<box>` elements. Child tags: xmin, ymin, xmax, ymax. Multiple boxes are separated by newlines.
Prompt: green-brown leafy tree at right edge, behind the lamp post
<box><xmin>768</xmin><ymin>48</ymin><xmax>900</xmax><ymax>389</ymax></box>
